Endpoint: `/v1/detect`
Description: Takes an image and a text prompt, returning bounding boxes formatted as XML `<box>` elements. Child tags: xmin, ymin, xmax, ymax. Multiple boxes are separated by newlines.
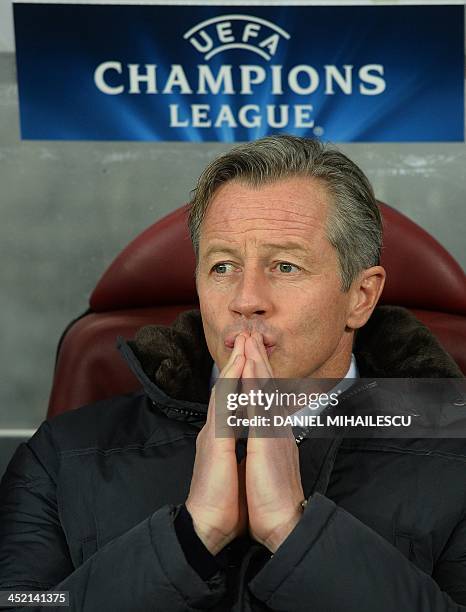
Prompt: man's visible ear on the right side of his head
<box><xmin>346</xmin><ymin>266</ymin><xmax>386</xmax><ymax>329</ymax></box>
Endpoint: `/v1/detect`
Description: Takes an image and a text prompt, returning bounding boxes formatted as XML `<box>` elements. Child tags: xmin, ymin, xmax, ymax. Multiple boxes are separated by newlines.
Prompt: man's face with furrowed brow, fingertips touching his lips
<box><xmin>197</xmin><ymin>177</ymin><xmax>352</xmax><ymax>378</ymax></box>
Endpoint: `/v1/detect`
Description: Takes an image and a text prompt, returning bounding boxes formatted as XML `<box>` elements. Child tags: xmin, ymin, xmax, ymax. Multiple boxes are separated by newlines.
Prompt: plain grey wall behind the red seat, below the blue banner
<box><xmin>0</xmin><ymin>27</ymin><xmax>466</xmax><ymax>473</ymax></box>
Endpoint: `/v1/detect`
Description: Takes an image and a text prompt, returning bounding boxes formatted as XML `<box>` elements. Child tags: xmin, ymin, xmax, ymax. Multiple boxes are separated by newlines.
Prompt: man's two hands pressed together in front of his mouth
<box><xmin>186</xmin><ymin>332</ymin><xmax>304</xmax><ymax>555</ymax></box>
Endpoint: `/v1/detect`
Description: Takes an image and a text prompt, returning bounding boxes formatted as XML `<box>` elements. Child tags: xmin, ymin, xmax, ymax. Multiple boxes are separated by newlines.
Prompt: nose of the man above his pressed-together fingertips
<box><xmin>229</xmin><ymin>267</ymin><xmax>272</xmax><ymax>318</ymax></box>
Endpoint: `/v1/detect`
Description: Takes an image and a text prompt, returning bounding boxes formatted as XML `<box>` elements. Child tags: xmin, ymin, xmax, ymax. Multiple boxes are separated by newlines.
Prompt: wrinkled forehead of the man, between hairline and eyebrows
<box><xmin>200</xmin><ymin>177</ymin><xmax>330</xmax><ymax>248</ymax></box>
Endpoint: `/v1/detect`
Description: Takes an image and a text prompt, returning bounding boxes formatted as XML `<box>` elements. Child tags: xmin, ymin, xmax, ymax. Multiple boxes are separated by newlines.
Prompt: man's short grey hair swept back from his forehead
<box><xmin>188</xmin><ymin>135</ymin><xmax>382</xmax><ymax>291</ymax></box>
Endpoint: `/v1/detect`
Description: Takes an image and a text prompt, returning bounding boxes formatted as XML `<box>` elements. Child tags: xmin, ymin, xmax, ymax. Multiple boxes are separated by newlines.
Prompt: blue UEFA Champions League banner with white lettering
<box><xmin>14</xmin><ymin>4</ymin><xmax>464</xmax><ymax>142</ymax></box>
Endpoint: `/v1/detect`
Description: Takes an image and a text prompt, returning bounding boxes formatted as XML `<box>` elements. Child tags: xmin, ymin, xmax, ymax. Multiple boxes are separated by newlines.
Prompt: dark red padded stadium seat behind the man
<box><xmin>48</xmin><ymin>204</ymin><xmax>466</xmax><ymax>417</ymax></box>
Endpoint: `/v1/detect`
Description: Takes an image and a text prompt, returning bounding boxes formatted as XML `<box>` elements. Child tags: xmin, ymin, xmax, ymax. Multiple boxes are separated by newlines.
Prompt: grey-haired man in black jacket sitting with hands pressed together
<box><xmin>0</xmin><ymin>136</ymin><xmax>466</xmax><ymax>612</ymax></box>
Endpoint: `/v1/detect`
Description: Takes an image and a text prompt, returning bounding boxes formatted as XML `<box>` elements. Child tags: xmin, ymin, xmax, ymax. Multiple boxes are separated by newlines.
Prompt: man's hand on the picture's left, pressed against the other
<box><xmin>186</xmin><ymin>334</ymin><xmax>247</xmax><ymax>555</ymax></box>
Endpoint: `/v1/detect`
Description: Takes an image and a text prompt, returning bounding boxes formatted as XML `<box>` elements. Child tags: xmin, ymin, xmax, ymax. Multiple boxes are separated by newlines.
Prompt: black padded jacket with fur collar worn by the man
<box><xmin>0</xmin><ymin>307</ymin><xmax>466</xmax><ymax>612</ymax></box>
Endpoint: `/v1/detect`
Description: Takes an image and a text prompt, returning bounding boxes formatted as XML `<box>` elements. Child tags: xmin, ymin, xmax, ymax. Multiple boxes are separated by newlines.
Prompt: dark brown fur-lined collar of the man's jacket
<box><xmin>128</xmin><ymin>306</ymin><xmax>462</xmax><ymax>404</ymax></box>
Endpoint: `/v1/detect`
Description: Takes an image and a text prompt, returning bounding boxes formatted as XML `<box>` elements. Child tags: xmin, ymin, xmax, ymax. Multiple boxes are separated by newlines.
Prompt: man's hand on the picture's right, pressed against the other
<box><xmin>242</xmin><ymin>332</ymin><xmax>304</xmax><ymax>552</ymax></box>
